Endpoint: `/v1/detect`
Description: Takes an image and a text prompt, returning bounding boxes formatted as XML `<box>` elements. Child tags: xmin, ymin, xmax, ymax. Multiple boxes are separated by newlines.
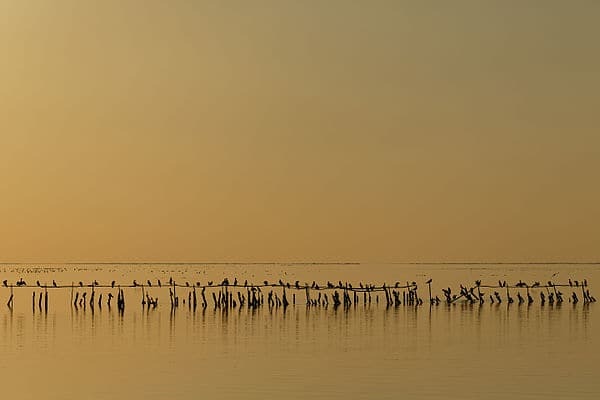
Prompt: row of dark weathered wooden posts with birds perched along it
<box><xmin>5</xmin><ymin>279</ymin><xmax>596</xmax><ymax>311</ymax></box>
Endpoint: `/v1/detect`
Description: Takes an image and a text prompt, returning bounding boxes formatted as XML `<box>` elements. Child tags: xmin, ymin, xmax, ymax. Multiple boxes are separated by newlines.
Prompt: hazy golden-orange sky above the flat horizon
<box><xmin>0</xmin><ymin>0</ymin><xmax>600</xmax><ymax>262</ymax></box>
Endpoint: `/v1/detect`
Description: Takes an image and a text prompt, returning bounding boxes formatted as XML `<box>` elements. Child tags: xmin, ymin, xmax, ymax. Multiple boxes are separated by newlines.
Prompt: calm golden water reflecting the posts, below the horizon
<box><xmin>0</xmin><ymin>264</ymin><xmax>600</xmax><ymax>399</ymax></box>
